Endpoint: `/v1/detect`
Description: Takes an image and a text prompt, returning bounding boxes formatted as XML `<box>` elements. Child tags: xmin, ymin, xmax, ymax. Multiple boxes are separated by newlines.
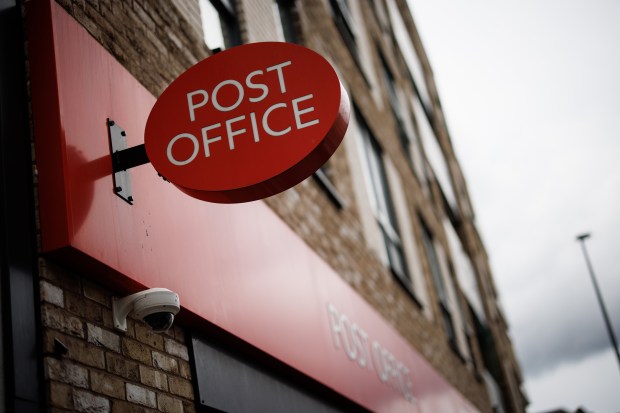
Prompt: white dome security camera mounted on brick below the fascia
<box><xmin>112</xmin><ymin>288</ymin><xmax>181</xmax><ymax>333</ymax></box>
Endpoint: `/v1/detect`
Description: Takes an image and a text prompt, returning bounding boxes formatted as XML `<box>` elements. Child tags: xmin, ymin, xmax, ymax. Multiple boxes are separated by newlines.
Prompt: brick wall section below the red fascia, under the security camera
<box><xmin>39</xmin><ymin>259</ymin><xmax>195</xmax><ymax>413</ymax></box>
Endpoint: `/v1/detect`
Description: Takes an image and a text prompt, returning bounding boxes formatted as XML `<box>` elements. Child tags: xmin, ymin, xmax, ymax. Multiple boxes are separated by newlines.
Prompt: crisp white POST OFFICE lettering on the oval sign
<box><xmin>166</xmin><ymin>60</ymin><xmax>319</xmax><ymax>166</ymax></box>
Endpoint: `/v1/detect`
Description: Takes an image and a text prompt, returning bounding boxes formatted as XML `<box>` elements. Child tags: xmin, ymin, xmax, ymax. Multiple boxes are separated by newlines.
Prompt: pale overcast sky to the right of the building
<box><xmin>409</xmin><ymin>0</ymin><xmax>620</xmax><ymax>413</ymax></box>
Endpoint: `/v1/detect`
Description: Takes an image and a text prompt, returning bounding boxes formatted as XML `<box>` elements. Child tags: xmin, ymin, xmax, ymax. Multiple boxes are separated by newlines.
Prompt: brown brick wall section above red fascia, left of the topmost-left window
<box><xmin>53</xmin><ymin>0</ymin><xmax>210</xmax><ymax>96</ymax></box>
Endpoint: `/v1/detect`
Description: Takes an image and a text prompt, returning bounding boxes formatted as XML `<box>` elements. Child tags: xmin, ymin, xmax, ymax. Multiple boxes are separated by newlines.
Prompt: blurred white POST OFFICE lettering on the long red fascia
<box><xmin>327</xmin><ymin>303</ymin><xmax>416</xmax><ymax>403</ymax></box>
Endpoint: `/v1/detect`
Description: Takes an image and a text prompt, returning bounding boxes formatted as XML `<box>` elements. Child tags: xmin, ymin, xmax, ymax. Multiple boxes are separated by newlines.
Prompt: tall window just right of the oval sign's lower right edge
<box><xmin>357</xmin><ymin>112</ymin><xmax>411</xmax><ymax>289</ymax></box>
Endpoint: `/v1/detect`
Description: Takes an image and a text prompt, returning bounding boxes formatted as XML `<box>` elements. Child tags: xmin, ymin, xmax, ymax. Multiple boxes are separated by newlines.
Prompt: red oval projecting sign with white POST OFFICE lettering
<box><xmin>144</xmin><ymin>42</ymin><xmax>350</xmax><ymax>203</ymax></box>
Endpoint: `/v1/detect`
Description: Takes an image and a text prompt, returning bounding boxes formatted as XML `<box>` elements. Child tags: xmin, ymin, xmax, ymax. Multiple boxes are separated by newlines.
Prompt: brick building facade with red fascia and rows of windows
<box><xmin>0</xmin><ymin>0</ymin><xmax>527</xmax><ymax>413</ymax></box>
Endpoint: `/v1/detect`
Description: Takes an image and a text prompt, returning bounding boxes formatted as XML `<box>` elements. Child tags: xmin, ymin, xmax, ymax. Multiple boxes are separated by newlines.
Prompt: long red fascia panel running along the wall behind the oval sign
<box><xmin>26</xmin><ymin>0</ymin><xmax>476</xmax><ymax>413</ymax></box>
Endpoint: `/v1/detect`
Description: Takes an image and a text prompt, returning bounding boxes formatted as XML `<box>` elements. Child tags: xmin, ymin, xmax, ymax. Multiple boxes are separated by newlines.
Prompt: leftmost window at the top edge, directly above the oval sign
<box><xmin>200</xmin><ymin>0</ymin><xmax>241</xmax><ymax>51</ymax></box>
